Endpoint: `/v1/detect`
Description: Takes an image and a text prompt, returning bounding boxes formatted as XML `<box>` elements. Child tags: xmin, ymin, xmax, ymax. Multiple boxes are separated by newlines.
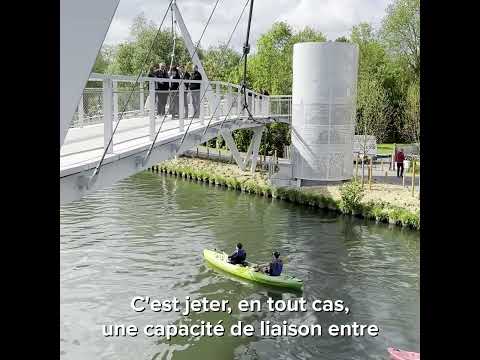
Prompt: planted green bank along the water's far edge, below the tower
<box><xmin>152</xmin><ymin>157</ymin><xmax>420</xmax><ymax>230</ymax></box>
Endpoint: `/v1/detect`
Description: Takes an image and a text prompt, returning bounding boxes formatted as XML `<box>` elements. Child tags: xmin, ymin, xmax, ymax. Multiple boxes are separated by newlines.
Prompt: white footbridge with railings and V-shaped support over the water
<box><xmin>60</xmin><ymin>74</ymin><xmax>291</xmax><ymax>203</ymax></box>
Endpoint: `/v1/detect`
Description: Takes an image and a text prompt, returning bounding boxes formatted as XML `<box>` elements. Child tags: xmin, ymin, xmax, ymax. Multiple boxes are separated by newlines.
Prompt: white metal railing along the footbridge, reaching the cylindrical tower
<box><xmin>70</xmin><ymin>74</ymin><xmax>276</xmax><ymax>128</ymax></box>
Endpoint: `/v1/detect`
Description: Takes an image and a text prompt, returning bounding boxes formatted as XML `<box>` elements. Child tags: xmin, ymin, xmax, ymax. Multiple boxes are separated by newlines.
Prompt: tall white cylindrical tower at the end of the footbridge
<box><xmin>292</xmin><ymin>42</ymin><xmax>358</xmax><ymax>181</ymax></box>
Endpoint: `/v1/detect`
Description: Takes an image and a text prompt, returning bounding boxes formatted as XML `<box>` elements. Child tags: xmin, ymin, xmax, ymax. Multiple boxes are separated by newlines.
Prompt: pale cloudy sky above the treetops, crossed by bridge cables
<box><xmin>104</xmin><ymin>0</ymin><xmax>391</xmax><ymax>52</ymax></box>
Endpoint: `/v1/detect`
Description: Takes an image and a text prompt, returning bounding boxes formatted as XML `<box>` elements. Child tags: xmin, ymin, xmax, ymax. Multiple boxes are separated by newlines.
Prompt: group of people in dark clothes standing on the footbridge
<box><xmin>148</xmin><ymin>63</ymin><xmax>202</xmax><ymax>118</ymax></box>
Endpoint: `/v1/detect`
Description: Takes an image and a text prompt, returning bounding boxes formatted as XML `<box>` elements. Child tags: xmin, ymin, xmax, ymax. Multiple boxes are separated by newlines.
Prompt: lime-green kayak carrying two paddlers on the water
<box><xmin>203</xmin><ymin>249</ymin><xmax>303</xmax><ymax>290</ymax></box>
